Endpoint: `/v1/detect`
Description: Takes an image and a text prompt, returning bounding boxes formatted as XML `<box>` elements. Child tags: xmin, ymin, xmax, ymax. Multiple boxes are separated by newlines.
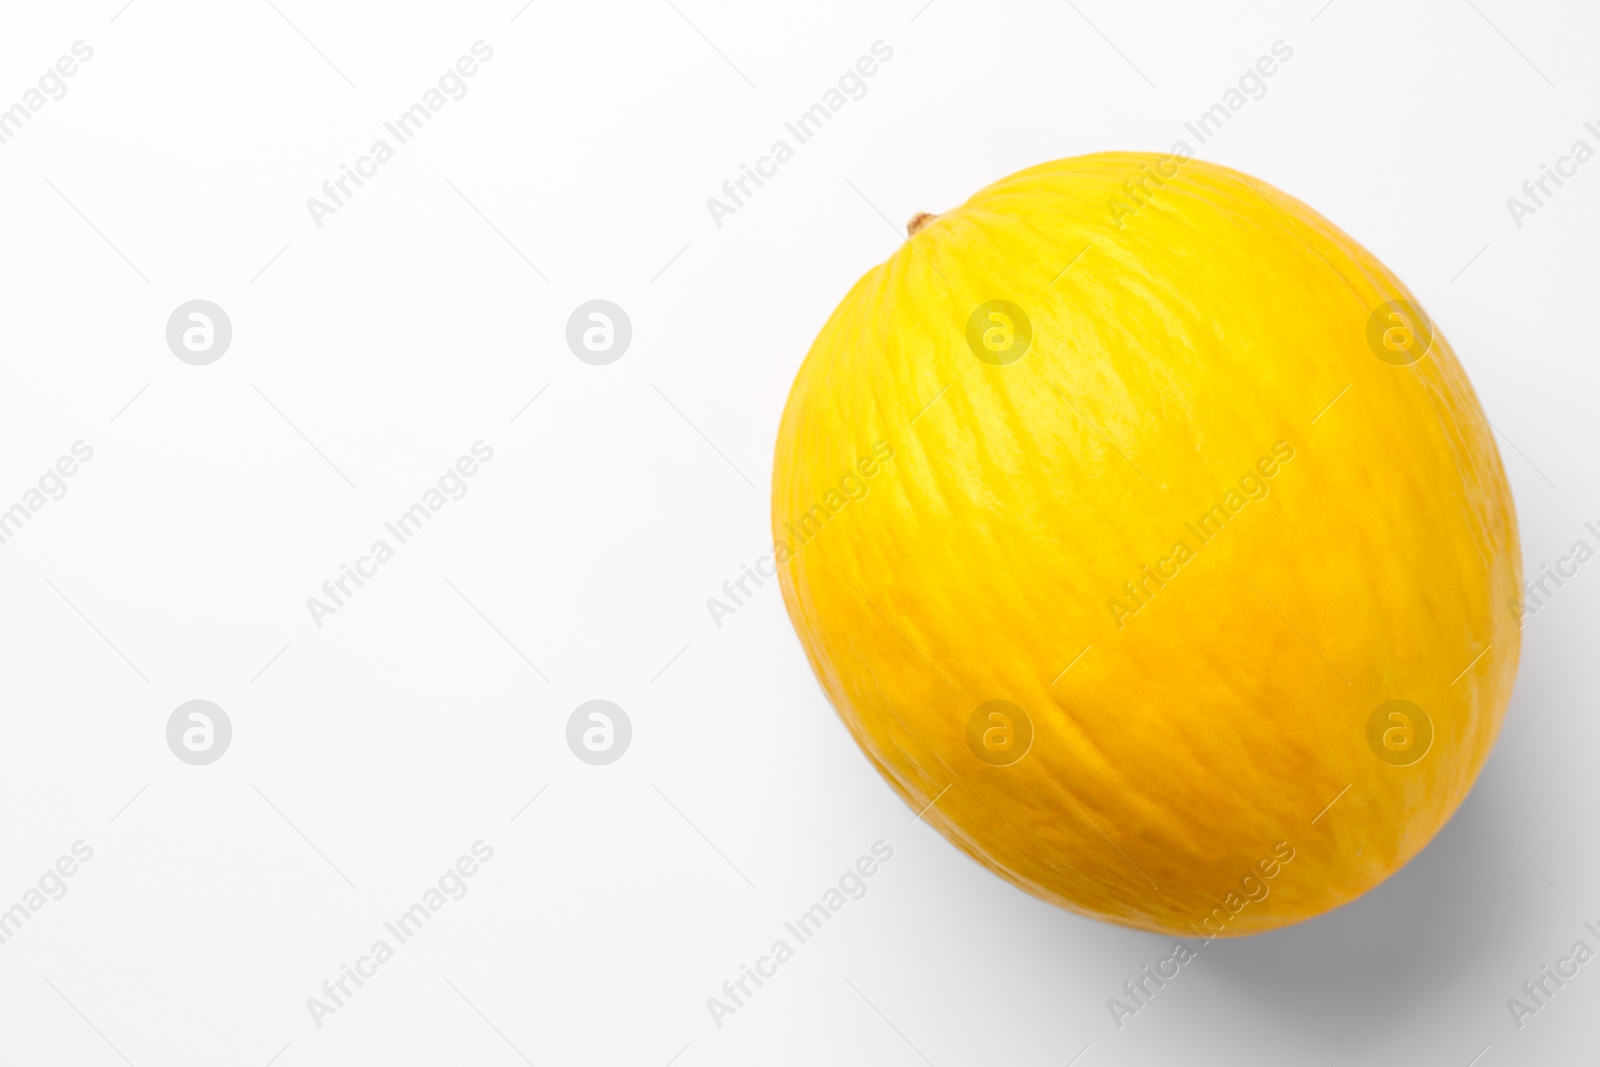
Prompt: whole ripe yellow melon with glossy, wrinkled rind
<box><xmin>773</xmin><ymin>152</ymin><xmax>1522</xmax><ymax>937</ymax></box>
